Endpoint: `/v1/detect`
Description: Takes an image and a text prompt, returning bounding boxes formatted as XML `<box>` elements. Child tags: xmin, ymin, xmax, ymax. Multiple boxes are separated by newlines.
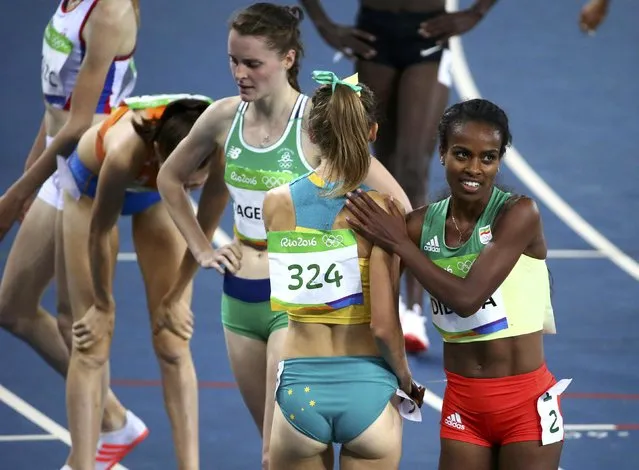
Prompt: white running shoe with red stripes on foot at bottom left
<box><xmin>95</xmin><ymin>410</ymin><xmax>149</xmax><ymax>470</ymax></box>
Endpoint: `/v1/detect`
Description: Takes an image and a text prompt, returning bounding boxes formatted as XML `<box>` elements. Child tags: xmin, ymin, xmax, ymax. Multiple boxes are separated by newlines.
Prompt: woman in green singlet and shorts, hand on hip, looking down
<box><xmin>158</xmin><ymin>3</ymin><xmax>410</xmax><ymax>468</ymax></box>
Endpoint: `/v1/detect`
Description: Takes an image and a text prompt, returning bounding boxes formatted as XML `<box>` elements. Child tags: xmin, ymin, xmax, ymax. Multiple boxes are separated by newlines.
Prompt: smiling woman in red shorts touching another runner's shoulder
<box><xmin>348</xmin><ymin>99</ymin><xmax>570</xmax><ymax>470</ymax></box>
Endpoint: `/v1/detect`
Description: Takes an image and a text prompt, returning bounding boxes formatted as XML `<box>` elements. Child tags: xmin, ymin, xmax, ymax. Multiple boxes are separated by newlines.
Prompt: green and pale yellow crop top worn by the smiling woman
<box><xmin>420</xmin><ymin>187</ymin><xmax>554</xmax><ymax>342</ymax></box>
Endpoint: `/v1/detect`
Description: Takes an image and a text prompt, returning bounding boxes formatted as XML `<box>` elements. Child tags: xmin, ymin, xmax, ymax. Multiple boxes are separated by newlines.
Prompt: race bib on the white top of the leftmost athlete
<box><xmin>41</xmin><ymin>22</ymin><xmax>73</xmax><ymax>96</ymax></box>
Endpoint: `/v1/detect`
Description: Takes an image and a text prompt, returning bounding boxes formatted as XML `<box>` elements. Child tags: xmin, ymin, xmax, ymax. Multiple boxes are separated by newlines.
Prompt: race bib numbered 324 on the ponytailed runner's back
<box><xmin>268</xmin><ymin>230</ymin><xmax>364</xmax><ymax>312</ymax></box>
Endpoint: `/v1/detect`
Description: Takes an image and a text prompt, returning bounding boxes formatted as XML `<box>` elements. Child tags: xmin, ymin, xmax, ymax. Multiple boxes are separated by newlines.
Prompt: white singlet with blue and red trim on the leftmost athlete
<box><xmin>41</xmin><ymin>0</ymin><xmax>137</xmax><ymax>114</ymax></box>
